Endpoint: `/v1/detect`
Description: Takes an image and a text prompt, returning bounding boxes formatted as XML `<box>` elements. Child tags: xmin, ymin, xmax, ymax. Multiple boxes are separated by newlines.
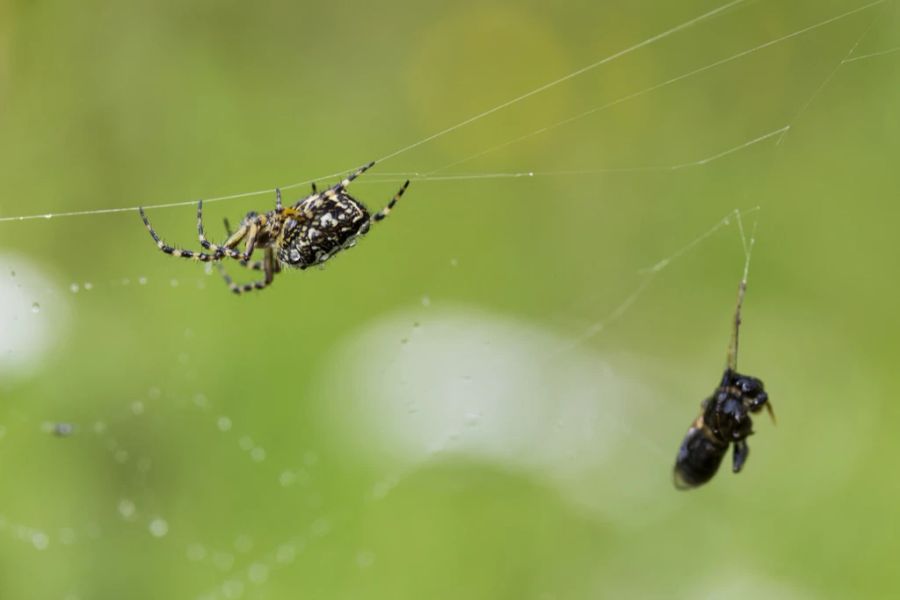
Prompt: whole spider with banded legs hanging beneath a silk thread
<box><xmin>138</xmin><ymin>162</ymin><xmax>409</xmax><ymax>294</ymax></box>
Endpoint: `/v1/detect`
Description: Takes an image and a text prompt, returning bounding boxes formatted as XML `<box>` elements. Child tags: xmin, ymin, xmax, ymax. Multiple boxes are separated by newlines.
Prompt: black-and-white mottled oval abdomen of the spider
<box><xmin>278</xmin><ymin>189</ymin><xmax>371</xmax><ymax>269</ymax></box>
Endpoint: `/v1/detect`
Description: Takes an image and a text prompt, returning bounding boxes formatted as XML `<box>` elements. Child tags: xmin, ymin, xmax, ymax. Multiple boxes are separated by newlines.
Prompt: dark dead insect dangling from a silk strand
<box><xmin>674</xmin><ymin>279</ymin><xmax>775</xmax><ymax>490</ymax></box>
